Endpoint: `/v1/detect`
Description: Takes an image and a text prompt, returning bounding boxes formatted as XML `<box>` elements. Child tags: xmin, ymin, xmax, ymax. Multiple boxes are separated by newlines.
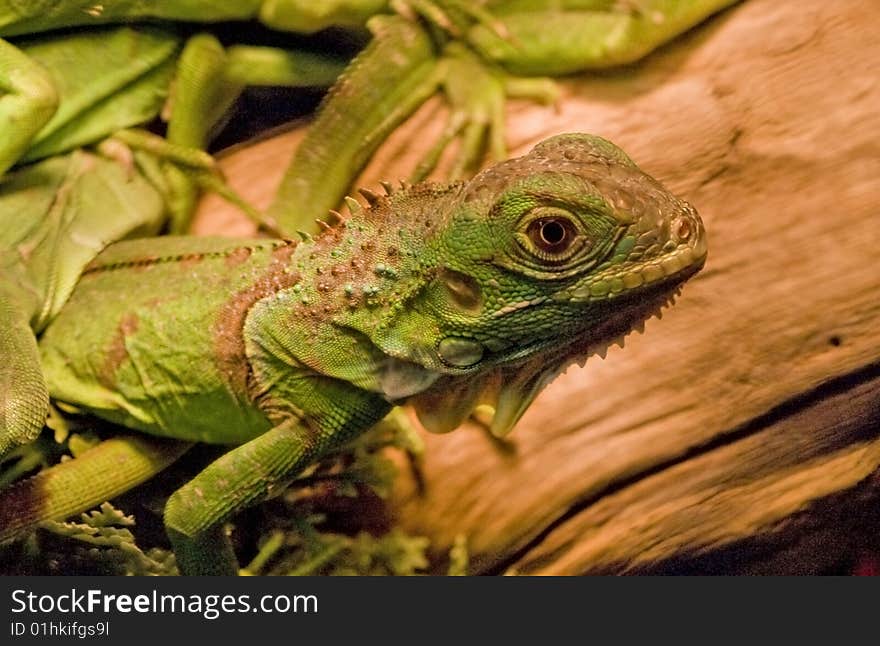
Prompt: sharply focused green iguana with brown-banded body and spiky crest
<box><xmin>0</xmin><ymin>134</ymin><xmax>706</xmax><ymax>574</ymax></box>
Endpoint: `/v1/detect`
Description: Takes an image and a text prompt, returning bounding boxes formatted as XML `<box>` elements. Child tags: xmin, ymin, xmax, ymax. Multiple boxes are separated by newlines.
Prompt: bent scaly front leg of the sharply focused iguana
<box><xmin>165</xmin><ymin>291</ymin><xmax>391</xmax><ymax>574</ymax></box>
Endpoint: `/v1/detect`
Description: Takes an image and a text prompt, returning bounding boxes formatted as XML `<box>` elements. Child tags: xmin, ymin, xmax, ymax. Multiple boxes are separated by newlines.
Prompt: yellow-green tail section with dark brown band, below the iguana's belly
<box><xmin>0</xmin><ymin>435</ymin><xmax>192</xmax><ymax>543</ymax></box>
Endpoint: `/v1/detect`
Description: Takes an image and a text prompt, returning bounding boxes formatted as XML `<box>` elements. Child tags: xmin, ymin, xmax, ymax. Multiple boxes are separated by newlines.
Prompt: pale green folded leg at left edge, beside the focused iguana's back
<box><xmin>0</xmin><ymin>151</ymin><xmax>164</xmax><ymax>456</ymax></box>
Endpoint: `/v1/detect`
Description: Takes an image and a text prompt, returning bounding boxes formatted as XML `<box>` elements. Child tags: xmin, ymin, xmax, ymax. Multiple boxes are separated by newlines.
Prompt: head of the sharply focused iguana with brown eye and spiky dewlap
<box><xmin>312</xmin><ymin>134</ymin><xmax>706</xmax><ymax>434</ymax></box>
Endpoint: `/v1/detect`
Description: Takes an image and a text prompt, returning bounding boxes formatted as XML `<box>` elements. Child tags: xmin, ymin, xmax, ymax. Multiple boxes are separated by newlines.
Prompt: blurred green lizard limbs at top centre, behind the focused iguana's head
<box><xmin>269</xmin><ymin>0</ymin><xmax>738</xmax><ymax>231</ymax></box>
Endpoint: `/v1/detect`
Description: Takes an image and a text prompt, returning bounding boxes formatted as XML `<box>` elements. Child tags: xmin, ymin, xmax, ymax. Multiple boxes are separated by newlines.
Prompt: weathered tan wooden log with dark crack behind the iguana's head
<box><xmin>194</xmin><ymin>0</ymin><xmax>880</xmax><ymax>574</ymax></box>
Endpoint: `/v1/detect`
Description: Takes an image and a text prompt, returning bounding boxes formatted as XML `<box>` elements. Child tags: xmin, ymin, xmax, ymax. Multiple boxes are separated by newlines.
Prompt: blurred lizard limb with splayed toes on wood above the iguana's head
<box><xmin>410</xmin><ymin>0</ymin><xmax>735</xmax><ymax>181</ymax></box>
